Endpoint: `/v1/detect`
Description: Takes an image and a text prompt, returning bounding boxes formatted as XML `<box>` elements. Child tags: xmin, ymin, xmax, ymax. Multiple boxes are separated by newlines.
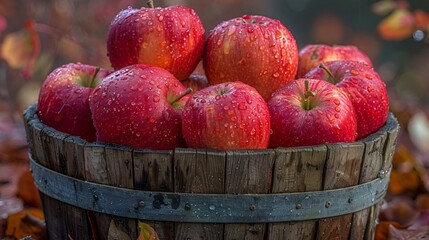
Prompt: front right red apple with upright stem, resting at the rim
<box><xmin>268</xmin><ymin>79</ymin><xmax>357</xmax><ymax>148</ymax></box>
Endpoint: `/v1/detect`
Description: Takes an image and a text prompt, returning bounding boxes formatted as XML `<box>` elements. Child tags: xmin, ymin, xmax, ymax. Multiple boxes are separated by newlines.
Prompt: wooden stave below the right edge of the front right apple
<box><xmin>316</xmin><ymin>142</ymin><xmax>365</xmax><ymax>239</ymax></box>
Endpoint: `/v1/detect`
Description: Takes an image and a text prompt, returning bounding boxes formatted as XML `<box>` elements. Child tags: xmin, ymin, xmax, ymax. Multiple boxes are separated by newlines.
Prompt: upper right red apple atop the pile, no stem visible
<box><xmin>203</xmin><ymin>15</ymin><xmax>298</xmax><ymax>99</ymax></box>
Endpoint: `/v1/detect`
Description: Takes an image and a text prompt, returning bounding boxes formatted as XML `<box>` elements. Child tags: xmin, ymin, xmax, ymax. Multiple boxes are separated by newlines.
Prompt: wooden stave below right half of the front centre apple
<box><xmin>224</xmin><ymin>150</ymin><xmax>275</xmax><ymax>239</ymax></box>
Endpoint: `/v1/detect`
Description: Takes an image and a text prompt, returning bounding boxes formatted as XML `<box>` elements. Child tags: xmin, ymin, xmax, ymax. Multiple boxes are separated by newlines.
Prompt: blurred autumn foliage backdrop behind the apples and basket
<box><xmin>0</xmin><ymin>0</ymin><xmax>429</xmax><ymax>236</ymax></box>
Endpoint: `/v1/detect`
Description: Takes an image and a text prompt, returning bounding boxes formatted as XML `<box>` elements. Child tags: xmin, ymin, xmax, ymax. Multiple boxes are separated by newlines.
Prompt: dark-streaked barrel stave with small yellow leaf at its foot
<box><xmin>133</xmin><ymin>150</ymin><xmax>174</xmax><ymax>239</ymax></box>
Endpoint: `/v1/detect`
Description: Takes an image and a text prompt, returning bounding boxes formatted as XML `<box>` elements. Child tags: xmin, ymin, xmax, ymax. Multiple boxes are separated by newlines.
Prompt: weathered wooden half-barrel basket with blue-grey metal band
<box><xmin>24</xmin><ymin>105</ymin><xmax>399</xmax><ymax>240</ymax></box>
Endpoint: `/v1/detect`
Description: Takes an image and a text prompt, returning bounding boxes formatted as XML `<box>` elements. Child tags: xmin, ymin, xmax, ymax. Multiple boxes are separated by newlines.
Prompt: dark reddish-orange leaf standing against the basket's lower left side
<box><xmin>17</xmin><ymin>171</ymin><xmax>42</xmax><ymax>208</ymax></box>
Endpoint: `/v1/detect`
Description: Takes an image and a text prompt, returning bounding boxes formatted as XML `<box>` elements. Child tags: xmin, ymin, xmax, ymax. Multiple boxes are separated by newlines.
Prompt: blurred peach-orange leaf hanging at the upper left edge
<box><xmin>0</xmin><ymin>20</ymin><xmax>40</xmax><ymax>79</ymax></box>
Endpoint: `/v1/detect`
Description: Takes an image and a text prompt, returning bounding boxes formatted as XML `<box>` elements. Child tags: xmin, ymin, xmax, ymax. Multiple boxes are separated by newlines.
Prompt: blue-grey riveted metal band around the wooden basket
<box><xmin>30</xmin><ymin>154</ymin><xmax>389</xmax><ymax>223</ymax></box>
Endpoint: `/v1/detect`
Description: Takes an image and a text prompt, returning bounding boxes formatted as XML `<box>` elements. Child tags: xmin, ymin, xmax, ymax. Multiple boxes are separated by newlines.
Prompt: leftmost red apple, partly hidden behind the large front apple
<box><xmin>37</xmin><ymin>63</ymin><xmax>110</xmax><ymax>142</ymax></box>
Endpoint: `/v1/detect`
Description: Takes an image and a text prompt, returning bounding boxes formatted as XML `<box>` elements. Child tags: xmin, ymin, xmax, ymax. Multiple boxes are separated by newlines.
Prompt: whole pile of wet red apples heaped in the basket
<box><xmin>38</xmin><ymin>3</ymin><xmax>389</xmax><ymax>150</ymax></box>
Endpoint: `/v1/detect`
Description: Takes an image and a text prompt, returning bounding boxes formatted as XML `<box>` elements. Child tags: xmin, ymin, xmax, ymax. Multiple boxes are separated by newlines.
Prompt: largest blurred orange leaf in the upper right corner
<box><xmin>377</xmin><ymin>8</ymin><xmax>415</xmax><ymax>41</ymax></box>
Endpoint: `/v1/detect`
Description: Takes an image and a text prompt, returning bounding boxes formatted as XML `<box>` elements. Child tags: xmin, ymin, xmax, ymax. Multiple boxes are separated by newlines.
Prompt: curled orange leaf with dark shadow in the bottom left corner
<box><xmin>6</xmin><ymin>208</ymin><xmax>46</xmax><ymax>239</ymax></box>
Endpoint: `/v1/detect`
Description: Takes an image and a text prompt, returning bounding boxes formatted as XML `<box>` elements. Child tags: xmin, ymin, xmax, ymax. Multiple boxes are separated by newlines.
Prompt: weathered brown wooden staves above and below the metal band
<box><xmin>24</xmin><ymin>106</ymin><xmax>399</xmax><ymax>239</ymax></box>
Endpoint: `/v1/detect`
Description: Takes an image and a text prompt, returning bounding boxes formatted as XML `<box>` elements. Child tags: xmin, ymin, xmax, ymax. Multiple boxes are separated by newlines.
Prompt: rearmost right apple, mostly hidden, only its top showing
<box><xmin>297</xmin><ymin>44</ymin><xmax>372</xmax><ymax>78</ymax></box>
